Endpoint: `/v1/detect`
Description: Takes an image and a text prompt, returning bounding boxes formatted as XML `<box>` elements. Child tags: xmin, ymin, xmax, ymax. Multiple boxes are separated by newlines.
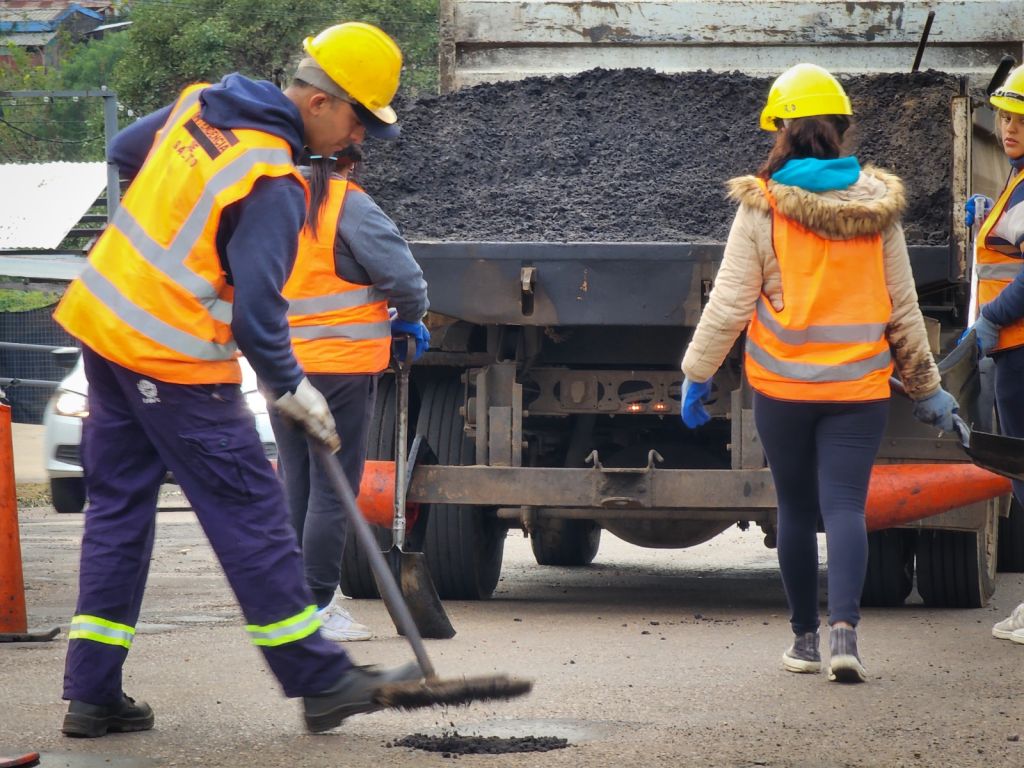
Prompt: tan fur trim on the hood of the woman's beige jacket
<box><xmin>726</xmin><ymin>166</ymin><xmax>906</xmax><ymax>240</ymax></box>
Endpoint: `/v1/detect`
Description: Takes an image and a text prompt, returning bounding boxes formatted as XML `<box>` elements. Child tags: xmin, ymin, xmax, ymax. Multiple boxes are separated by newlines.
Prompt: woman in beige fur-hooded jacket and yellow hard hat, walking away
<box><xmin>682</xmin><ymin>63</ymin><xmax>956</xmax><ymax>682</ymax></box>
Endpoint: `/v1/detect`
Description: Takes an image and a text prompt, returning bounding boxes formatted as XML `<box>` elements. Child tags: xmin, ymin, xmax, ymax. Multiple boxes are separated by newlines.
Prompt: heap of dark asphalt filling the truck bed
<box><xmin>358</xmin><ymin>70</ymin><xmax>958</xmax><ymax>245</ymax></box>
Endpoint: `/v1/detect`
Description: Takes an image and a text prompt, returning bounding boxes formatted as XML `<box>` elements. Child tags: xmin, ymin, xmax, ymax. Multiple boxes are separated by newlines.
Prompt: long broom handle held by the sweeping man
<box><xmin>306</xmin><ymin>437</ymin><xmax>435</xmax><ymax>678</ymax></box>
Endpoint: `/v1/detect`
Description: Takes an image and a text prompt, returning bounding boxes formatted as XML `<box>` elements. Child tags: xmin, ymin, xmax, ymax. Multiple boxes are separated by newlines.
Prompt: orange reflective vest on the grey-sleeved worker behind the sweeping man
<box><xmin>282</xmin><ymin>176</ymin><xmax>391</xmax><ymax>374</ymax></box>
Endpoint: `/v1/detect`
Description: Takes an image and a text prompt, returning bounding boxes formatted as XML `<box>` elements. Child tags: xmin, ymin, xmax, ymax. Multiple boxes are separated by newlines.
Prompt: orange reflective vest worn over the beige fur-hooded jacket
<box><xmin>744</xmin><ymin>180</ymin><xmax>893</xmax><ymax>402</ymax></box>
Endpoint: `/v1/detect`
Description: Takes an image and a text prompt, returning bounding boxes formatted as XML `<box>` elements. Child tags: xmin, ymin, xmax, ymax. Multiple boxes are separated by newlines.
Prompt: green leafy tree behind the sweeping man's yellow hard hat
<box><xmin>114</xmin><ymin>0</ymin><xmax>437</xmax><ymax>113</ymax></box>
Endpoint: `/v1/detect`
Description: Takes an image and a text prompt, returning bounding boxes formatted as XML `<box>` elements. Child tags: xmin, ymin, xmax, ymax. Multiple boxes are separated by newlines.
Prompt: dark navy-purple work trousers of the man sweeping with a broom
<box><xmin>63</xmin><ymin>348</ymin><xmax>351</xmax><ymax>705</ymax></box>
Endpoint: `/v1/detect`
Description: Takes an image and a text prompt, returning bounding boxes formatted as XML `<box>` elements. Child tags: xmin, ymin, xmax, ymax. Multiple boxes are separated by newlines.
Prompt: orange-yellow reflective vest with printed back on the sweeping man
<box><xmin>54</xmin><ymin>83</ymin><xmax>308</xmax><ymax>384</ymax></box>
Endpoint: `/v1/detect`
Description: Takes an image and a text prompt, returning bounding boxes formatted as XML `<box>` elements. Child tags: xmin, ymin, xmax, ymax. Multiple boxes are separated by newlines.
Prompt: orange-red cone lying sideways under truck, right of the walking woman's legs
<box><xmin>865</xmin><ymin>464</ymin><xmax>1012</xmax><ymax>530</ymax></box>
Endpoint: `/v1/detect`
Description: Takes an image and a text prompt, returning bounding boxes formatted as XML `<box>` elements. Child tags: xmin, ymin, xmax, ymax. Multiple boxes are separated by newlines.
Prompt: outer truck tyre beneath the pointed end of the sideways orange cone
<box><xmin>916</xmin><ymin>504</ymin><xmax>999</xmax><ymax>608</ymax></box>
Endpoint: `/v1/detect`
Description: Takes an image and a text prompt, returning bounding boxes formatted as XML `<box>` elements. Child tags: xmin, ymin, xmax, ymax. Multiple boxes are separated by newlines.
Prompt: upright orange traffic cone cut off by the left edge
<box><xmin>0</xmin><ymin>402</ymin><xmax>29</xmax><ymax>634</ymax></box>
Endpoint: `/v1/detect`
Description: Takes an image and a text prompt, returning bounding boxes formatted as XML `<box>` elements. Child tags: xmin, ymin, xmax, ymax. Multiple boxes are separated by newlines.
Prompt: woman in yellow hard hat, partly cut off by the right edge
<box><xmin>968</xmin><ymin>67</ymin><xmax>1024</xmax><ymax>645</ymax></box>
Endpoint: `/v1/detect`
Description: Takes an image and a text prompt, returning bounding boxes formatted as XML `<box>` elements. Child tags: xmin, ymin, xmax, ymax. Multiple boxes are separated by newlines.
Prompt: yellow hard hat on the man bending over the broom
<box><xmin>302</xmin><ymin>22</ymin><xmax>401</xmax><ymax>124</ymax></box>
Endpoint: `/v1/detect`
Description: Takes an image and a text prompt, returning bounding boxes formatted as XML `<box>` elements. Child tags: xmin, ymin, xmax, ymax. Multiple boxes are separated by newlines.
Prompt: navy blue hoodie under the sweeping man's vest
<box><xmin>109</xmin><ymin>74</ymin><xmax>306</xmax><ymax>397</ymax></box>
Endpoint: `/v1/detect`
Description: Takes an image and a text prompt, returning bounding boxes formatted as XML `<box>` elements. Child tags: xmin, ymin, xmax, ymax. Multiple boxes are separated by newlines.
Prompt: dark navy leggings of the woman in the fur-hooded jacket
<box><xmin>754</xmin><ymin>393</ymin><xmax>889</xmax><ymax>634</ymax></box>
